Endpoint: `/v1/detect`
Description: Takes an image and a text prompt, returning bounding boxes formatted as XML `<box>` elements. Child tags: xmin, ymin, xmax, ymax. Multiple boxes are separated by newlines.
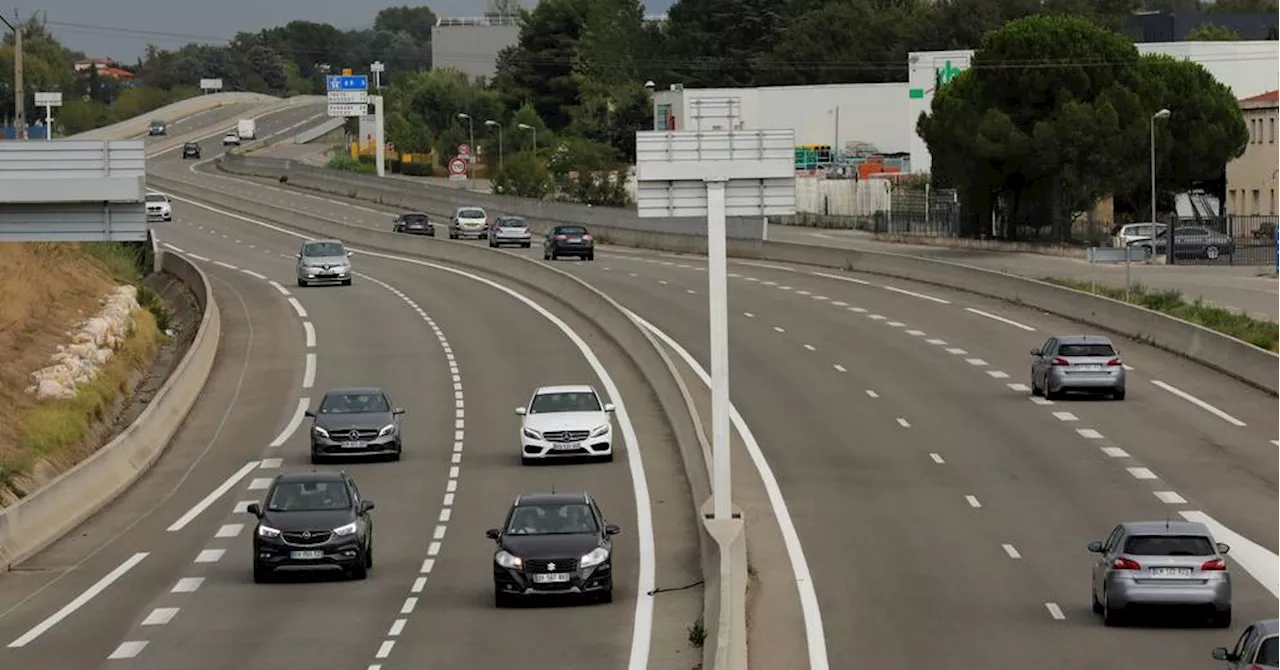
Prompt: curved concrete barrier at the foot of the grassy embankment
<box><xmin>0</xmin><ymin>254</ymin><xmax>221</xmax><ymax>570</ymax></box>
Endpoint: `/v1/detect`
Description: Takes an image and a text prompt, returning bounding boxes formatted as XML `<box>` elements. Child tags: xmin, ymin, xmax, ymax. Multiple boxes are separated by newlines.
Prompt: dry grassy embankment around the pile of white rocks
<box><xmin>0</xmin><ymin>242</ymin><xmax>169</xmax><ymax>497</ymax></box>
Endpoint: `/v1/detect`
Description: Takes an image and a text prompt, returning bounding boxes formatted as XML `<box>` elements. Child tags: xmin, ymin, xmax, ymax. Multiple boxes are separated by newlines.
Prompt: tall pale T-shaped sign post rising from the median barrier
<box><xmin>636</xmin><ymin>131</ymin><xmax>795</xmax><ymax>521</ymax></box>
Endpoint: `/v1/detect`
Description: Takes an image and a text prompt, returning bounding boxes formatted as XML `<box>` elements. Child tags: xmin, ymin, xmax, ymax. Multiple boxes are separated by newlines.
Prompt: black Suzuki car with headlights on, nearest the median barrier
<box><xmin>485</xmin><ymin>493</ymin><xmax>621</xmax><ymax>607</ymax></box>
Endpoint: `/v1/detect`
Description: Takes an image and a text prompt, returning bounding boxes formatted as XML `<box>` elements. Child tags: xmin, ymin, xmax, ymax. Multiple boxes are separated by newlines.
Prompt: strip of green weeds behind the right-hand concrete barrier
<box><xmin>1042</xmin><ymin>277</ymin><xmax>1280</xmax><ymax>354</ymax></box>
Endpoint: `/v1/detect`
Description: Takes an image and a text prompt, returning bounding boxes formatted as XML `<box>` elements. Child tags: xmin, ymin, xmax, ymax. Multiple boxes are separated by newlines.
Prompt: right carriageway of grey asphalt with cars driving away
<box><xmin>160</xmin><ymin>107</ymin><xmax>1280</xmax><ymax>669</ymax></box>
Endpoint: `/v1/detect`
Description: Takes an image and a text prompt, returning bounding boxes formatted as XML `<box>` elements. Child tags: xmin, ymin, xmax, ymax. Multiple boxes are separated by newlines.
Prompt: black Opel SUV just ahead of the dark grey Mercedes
<box><xmin>246</xmin><ymin>473</ymin><xmax>374</xmax><ymax>583</ymax></box>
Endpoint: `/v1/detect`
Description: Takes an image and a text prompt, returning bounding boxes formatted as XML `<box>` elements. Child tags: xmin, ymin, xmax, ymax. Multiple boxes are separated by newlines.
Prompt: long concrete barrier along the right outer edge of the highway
<box><xmin>218</xmin><ymin>156</ymin><xmax>1280</xmax><ymax>396</ymax></box>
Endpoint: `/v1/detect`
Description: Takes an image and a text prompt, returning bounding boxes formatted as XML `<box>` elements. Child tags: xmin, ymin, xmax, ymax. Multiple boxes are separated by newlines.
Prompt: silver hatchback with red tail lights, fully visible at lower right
<box><xmin>1089</xmin><ymin>521</ymin><xmax>1231</xmax><ymax>628</ymax></box>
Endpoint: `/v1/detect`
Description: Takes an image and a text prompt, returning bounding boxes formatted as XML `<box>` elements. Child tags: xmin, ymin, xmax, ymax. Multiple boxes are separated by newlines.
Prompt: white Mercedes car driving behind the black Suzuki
<box><xmin>516</xmin><ymin>384</ymin><xmax>613</xmax><ymax>465</ymax></box>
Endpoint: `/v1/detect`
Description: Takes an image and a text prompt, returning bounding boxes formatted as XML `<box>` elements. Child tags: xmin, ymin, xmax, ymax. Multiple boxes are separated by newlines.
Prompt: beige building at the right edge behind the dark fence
<box><xmin>1226</xmin><ymin>90</ymin><xmax>1280</xmax><ymax>215</ymax></box>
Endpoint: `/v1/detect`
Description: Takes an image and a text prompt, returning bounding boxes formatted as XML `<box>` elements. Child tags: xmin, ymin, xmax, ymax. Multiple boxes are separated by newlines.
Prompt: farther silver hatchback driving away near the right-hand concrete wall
<box><xmin>1032</xmin><ymin>336</ymin><xmax>1125</xmax><ymax>400</ymax></box>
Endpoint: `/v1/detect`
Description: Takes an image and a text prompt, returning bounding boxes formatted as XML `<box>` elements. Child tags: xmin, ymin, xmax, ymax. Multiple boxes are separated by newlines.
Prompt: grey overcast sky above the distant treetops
<box><xmin>20</xmin><ymin>0</ymin><xmax>671</xmax><ymax>63</ymax></box>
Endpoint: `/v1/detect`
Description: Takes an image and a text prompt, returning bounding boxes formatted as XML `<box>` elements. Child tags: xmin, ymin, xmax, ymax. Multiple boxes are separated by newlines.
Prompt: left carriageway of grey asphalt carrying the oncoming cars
<box><xmin>0</xmin><ymin>101</ymin><xmax>701</xmax><ymax>669</ymax></box>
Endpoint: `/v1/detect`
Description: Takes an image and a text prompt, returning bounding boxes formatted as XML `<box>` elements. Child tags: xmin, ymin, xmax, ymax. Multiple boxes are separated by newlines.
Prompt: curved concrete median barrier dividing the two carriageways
<box><xmin>151</xmin><ymin>174</ymin><xmax>746</xmax><ymax>670</ymax></box>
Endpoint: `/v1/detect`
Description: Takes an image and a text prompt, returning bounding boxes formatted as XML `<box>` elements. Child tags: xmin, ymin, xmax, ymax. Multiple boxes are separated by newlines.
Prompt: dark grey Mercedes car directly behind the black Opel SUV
<box><xmin>307</xmin><ymin>387</ymin><xmax>404</xmax><ymax>462</ymax></box>
